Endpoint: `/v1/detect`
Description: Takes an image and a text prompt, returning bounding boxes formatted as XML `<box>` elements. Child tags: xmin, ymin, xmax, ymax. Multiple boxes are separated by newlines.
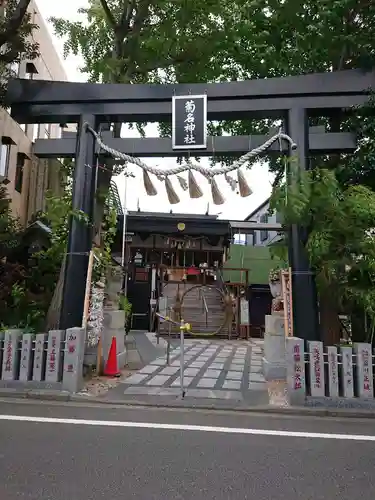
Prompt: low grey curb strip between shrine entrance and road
<box><xmin>0</xmin><ymin>388</ymin><xmax>375</xmax><ymax>419</ymax></box>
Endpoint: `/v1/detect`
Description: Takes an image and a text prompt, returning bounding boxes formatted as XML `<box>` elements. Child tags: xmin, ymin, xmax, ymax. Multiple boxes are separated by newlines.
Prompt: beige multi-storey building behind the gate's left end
<box><xmin>0</xmin><ymin>1</ymin><xmax>67</xmax><ymax>225</ymax></box>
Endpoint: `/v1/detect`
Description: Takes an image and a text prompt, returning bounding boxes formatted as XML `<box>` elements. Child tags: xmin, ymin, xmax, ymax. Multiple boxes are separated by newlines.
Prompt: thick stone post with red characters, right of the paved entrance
<box><xmin>285</xmin><ymin>337</ymin><xmax>306</xmax><ymax>404</ymax></box>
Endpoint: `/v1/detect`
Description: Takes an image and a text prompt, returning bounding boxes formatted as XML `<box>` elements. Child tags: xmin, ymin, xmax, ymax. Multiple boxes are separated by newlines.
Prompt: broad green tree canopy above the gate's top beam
<box><xmin>53</xmin><ymin>0</ymin><xmax>375</xmax><ymax>340</ymax></box>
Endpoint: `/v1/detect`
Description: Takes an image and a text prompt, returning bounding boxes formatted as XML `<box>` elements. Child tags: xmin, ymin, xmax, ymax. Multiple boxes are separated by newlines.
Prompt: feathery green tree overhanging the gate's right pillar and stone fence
<box><xmin>271</xmin><ymin>169</ymin><xmax>375</xmax><ymax>344</ymax></box>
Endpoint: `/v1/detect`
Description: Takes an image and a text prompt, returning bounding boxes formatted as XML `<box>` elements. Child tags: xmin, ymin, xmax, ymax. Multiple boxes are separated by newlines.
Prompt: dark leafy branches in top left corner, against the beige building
<box><xmin>0</xmin><ymin>0</ymin><xmax>39</xmax><ymax>102</ymax></box>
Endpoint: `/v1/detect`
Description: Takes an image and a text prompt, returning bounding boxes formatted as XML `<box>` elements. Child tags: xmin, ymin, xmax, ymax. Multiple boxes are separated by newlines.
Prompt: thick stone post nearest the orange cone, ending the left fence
<box><xmin>63</xmin><ymin>328</ymin><xmax>86</xmax><ymax>393</ymax></box>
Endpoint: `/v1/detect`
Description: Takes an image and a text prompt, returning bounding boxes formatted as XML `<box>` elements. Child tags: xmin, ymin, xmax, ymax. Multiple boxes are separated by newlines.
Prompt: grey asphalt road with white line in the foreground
<box><xmin>0</xmin><ymin>403</ymin><xmax>375</xmax><ymax>500</ymax></box>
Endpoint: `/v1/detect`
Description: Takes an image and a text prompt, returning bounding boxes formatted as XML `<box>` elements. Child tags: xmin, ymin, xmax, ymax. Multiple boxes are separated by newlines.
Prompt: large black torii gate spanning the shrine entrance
<box><xmin>7</xmin><ymin>70</ymin><xmax>375</xmax><ymax>340</ymax></box>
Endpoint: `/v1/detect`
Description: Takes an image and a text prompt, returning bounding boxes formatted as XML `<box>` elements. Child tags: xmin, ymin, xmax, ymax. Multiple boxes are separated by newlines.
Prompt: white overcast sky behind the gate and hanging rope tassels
<box><xmin>36</xmin><ymin>0</ymin><xmax>272</xmax><ymax>220</ymax></box>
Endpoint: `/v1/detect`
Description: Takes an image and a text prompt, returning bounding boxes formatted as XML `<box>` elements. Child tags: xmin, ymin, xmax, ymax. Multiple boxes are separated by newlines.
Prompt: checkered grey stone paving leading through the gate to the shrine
<box><xmin>117</xmin><ymin>334</ymin><xmax>267</xmax><ymax>401</ymax></box>
